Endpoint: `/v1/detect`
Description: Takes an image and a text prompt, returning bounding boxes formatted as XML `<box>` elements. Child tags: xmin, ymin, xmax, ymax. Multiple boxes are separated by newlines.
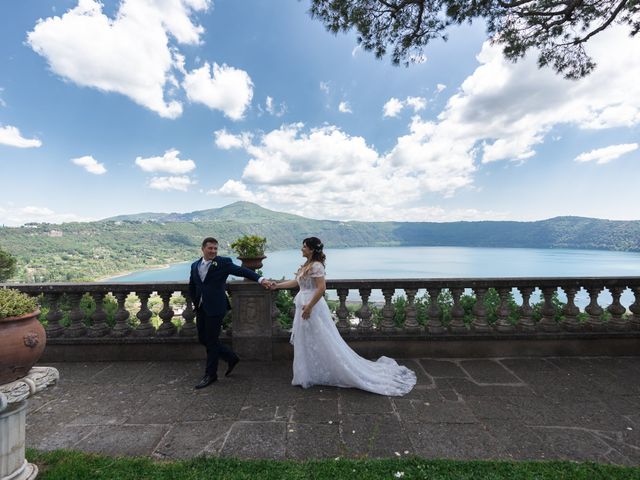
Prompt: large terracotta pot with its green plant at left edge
<box><xmin>0</xmin><ymin>288</ymin><xmax>46</xmax><ymax>385</ymax></box>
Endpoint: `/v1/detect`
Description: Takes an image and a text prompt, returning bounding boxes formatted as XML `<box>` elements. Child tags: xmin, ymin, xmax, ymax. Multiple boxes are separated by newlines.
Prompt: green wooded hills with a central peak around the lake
<box><xmin>0</xmin><ymin>202</ymin><xmax>640</xmax><ymax>282</ymax></box>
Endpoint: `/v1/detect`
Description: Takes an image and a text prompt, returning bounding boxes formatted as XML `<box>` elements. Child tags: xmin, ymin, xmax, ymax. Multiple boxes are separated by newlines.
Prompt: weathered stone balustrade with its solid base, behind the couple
<box><xmin>2</xmin><ymin>277</ymin><xmax>640</xmax><ymax>361</ymax></box>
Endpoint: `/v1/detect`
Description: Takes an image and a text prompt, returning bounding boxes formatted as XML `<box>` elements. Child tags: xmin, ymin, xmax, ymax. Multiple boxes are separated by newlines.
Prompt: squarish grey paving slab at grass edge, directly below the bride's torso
<box><xmin>286</xmin><ymin>423</ymin><xmax>345</xmax><ymax>460</ymax></box>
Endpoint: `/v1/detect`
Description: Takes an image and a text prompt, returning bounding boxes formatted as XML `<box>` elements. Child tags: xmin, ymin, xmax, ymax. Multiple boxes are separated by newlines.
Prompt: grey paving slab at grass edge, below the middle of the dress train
<box><xmin>341</xmin><ymin>414</ymin><xmax>415</xmax><ymax>458</ymax></box>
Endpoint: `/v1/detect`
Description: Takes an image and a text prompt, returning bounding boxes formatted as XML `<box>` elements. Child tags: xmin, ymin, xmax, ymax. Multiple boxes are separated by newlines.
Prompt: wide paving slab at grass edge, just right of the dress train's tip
<box><xmin>406</xmin><ymin>423</ymin><xmax>508</xmax><ymax>460</ymax></box>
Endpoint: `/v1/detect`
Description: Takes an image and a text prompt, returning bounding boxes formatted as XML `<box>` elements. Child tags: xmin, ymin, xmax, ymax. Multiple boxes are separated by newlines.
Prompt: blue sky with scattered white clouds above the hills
<box><xmin>0</xmin><ymin>0</ymin><xmax>640</xmax><ymax>226</ymax></box>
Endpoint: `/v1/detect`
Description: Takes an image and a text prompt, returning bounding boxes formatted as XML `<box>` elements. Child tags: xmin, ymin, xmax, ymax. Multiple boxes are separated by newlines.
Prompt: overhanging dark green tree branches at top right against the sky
<box><xmin>310</xmin><ymin>0</ymin><xmax>640</xmax><ymax>79</ymax></box>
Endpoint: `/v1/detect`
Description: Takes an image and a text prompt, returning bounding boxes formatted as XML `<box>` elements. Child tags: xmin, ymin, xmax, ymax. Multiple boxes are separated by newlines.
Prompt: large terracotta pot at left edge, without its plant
<box><xmin>0</xmin><ymin>310</ymin><xmax>47</xmax><ymax>385</ymax></box>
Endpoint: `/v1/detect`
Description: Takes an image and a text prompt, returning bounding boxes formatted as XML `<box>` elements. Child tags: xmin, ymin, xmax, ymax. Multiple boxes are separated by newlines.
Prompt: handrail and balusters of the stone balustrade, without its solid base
<box><xmin>5</xmin><ymin>277</ymin><xmax>640</xmax><ymax>341</ymax></box>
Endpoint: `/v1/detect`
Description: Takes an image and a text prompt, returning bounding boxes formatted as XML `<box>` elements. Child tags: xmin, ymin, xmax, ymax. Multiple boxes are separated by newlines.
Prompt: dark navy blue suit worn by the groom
<box><xmin>189</xmin><ymin>257</ymin><xmax>260</xmax><ymax>378</ymax></box>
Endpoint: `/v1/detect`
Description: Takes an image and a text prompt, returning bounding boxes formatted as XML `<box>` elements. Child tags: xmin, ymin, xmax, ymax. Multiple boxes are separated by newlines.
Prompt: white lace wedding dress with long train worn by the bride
<box><xmin>291</xmin><ymin>262</ymin><xmax>416</xmax><ymax>396</ymax></box>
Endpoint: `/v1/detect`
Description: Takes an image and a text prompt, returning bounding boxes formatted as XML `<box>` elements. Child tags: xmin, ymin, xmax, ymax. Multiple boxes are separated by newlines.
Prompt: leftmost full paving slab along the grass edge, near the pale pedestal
<box><xmin>74</xmin><ymin>425</ymin><xmax>169</xmax><ymax>457</ymax></box>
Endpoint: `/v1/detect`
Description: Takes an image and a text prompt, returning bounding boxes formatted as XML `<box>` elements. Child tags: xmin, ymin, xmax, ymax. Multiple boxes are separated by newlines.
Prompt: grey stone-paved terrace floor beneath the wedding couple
<box><xmin>27</xmin><ymin>357</ymin><xmax>640</xmax><ymax>465</ymax></box>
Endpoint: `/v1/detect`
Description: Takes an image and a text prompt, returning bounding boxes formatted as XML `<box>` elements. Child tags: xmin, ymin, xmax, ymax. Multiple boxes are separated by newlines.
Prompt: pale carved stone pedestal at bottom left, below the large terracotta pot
<box><xmin>0</xmin><ymin>367</ymin><xmax>60</xmax><ymax>480</ymax></box>
